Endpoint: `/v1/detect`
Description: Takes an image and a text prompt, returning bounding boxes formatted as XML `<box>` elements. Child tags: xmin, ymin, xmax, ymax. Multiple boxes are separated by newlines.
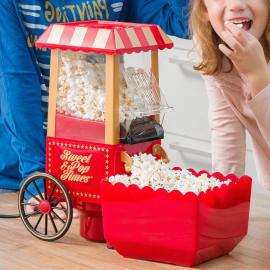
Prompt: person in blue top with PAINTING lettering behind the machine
<box><xmin>0</xmin><ymin>0</ymin><xmax>188</xmax><ymax>189</ymax></box>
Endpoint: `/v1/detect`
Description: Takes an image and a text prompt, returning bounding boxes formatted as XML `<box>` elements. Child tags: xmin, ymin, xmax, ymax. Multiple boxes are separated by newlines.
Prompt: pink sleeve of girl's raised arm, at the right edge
<box><xmin>248</xmin><ymin>85</ymin><xmax>270</xmax><ymax>146</ymax></box>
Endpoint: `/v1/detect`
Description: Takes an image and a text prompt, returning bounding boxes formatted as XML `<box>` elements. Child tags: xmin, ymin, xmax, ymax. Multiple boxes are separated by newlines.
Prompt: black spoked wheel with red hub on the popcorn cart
<box><xmin>19</xmin><ymin>173</ymin><xmax>73</xmax><ymax>241</ymax></box>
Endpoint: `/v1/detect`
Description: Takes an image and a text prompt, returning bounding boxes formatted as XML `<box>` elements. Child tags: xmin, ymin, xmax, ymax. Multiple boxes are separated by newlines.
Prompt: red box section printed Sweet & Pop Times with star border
<box><xmin>46</xmin><ymin>137</ymin><xmax>157</xmax><ymax>206</ymax></box>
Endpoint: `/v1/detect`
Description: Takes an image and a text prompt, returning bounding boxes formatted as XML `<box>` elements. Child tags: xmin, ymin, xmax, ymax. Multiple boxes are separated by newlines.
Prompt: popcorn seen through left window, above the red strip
<box><xmin>57</xmin><ymin>51</ymin><xmax>105</xmax><ymax>121</ymax></box>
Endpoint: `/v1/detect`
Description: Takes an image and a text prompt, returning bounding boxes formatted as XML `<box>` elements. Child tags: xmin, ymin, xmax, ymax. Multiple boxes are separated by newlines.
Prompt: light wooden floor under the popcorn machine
<box><xmin>0</xmin><ymin>194</ymin><xmax>270</xmax><ymax>270</ymax></box>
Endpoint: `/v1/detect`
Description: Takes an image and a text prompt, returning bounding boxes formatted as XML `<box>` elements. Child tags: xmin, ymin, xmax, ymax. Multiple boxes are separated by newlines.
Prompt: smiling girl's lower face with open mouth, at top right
<box><xmin>203</xmin><ymin>0</ymin><xmax>269</xmax><ymax>39</ymax></box>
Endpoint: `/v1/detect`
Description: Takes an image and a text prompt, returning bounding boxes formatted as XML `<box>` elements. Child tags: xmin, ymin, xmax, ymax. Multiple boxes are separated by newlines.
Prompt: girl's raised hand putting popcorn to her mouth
<box><xmin>219</xmin><ymin>22</ymin><xmax>270</xmax><ymax>97</ymax></box>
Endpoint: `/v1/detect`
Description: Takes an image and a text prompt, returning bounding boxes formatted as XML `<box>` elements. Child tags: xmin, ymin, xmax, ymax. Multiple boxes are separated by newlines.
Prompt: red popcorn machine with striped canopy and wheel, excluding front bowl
<box><xmin>19</xmin><ymin>21</ymin><xmax>173</xmax><ymax>241</ymax></box>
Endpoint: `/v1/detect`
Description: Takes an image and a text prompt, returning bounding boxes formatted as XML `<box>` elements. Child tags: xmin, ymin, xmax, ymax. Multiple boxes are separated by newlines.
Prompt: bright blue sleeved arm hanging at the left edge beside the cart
<box><xmin>0</xmin><ymin>0</ymin><xmax>45</xmax><ymax>189</ymax></box>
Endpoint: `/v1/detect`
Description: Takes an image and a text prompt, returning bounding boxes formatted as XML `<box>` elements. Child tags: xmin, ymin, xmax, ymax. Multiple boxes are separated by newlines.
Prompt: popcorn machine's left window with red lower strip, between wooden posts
<box><xmin>55</xmin><ymin>51</ymin><xmax>105</xmax><ymax>143</ymax></box>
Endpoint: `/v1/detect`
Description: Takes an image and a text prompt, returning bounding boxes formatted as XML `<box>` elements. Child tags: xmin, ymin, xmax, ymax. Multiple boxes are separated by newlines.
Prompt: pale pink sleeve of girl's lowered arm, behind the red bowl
<box><xmin>206</xmin><ymin>79</ymin><xmax>246</xmax><ymax>176</ymax></box>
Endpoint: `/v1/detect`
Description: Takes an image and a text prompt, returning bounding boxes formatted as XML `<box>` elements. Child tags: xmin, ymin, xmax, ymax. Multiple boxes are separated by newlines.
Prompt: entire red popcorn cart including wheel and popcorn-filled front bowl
<box><xmin>16</xmin><ymin>21</ymin><xmax>251</xmax><ymax>266</ymax></box>
